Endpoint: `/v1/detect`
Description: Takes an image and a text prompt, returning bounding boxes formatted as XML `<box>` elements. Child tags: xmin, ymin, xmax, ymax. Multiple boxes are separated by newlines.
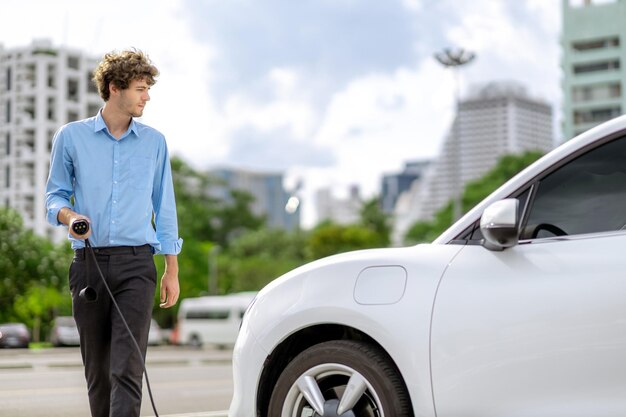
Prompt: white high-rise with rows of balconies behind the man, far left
<box><xmin>0</xmin><ymin>40</ymin><xmax>102</xmax><ymax>240</ymax></box>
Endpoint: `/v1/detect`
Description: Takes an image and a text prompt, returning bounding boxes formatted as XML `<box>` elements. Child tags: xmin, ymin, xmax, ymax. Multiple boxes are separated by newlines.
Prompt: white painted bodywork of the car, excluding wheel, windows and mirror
<box><xmin>229</xmin><ymin>116</ymin><xmax>626</xmax><ymax>417</ymax></box>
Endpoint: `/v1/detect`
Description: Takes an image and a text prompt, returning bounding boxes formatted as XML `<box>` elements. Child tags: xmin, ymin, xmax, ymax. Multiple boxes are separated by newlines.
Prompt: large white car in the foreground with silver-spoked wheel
<box><xmin>229</xmin><ymin>116</ymin><xmax>626</xmax><ymax>417</ymax></box>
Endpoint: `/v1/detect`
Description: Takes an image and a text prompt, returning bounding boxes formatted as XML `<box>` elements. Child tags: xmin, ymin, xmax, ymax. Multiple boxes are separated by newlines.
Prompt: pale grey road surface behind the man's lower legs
<box><xmin>0</xmin><ymin>346</ymin><xmax>233</xmax><ymax>417</ymax></box>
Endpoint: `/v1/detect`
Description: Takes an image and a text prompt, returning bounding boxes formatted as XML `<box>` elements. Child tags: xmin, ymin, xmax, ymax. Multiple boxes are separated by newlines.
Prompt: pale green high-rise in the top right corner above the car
<box><xmin>561</xmin><ymin>0</ymin><xmax>626</xmax><ymax>140</ymax></box>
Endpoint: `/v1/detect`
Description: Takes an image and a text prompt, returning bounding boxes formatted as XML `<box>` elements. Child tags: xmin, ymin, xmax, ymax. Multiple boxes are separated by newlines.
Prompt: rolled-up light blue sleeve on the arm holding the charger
<box><xmin>46</xmin><ymin>129</ymin><xmax>73</xmax><ymax>226</ymax></box>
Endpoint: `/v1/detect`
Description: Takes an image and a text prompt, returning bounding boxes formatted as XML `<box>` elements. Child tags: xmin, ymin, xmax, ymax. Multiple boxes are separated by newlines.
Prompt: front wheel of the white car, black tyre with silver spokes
<box><xmin>268</xmin><ymin>340</ymin><xmax>413</xmax><ymax>417</ymax></box>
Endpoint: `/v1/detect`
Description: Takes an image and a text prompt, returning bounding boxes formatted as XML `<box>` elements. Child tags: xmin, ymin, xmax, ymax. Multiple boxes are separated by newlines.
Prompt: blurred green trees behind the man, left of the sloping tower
<box><xmin>0</xmin><ymin>158</ymin><xmax>391</xmax><ymax>339</ymax></box>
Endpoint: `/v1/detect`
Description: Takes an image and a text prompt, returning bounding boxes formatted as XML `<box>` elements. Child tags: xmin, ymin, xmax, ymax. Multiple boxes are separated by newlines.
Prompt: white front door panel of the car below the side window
<box><xmin>432</xmin><ymin>232</ymin><xmax>626</xmax><ymax>417</ymax></box>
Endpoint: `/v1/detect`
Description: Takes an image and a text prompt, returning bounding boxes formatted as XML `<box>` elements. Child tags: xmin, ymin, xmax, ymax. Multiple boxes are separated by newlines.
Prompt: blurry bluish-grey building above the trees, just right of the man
<box><xmin>210</xmin><ymin>168</ymin><xmax>300</xmax><ymax>230</ymax></box>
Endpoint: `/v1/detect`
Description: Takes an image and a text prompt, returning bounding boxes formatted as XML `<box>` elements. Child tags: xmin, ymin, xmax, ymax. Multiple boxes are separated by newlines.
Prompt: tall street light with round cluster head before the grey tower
<box><xmin>435</xmin><ymin>48</ymin><xmax>476</xmax><ymax>221</ymax></box>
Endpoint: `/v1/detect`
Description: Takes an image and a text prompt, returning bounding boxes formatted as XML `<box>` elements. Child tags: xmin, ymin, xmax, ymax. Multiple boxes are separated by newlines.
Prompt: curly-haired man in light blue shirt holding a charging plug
<box><xmin>46</xmin><ymin>50</ymin><xmax>182</xmax><ymax>417</ymax></box>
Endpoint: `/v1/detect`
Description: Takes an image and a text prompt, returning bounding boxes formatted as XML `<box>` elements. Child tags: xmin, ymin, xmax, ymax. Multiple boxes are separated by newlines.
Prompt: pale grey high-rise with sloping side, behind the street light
<box><xmin>392</xmin><ymin>82</ymin><xmax>553</xmax><ymax>244</ymax></box>
